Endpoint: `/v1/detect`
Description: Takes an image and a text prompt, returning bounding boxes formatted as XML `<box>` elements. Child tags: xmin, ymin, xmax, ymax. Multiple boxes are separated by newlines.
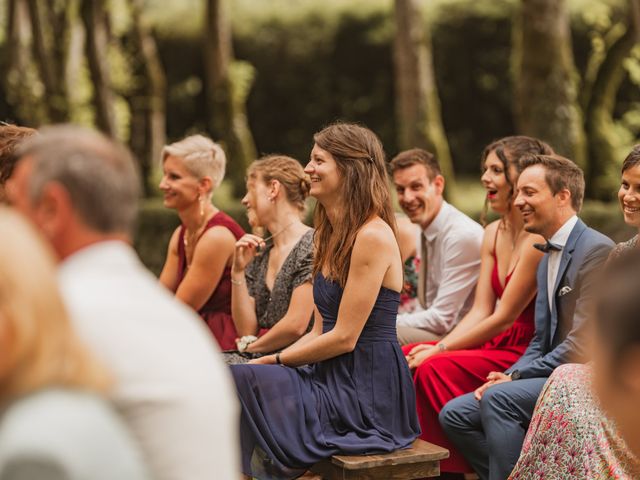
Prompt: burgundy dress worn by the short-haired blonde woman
<box><xmin>178</xmin><ymin>212</ymin><xmax>244</xmax><ymax>350</ymax></box>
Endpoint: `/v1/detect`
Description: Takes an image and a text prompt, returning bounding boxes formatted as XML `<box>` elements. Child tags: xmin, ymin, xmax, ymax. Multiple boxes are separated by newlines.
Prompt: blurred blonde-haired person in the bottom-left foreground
<box><xmin>0</xmin><ymin>207</ymin><xmax>151</xmax><ymax>480</ymax></box>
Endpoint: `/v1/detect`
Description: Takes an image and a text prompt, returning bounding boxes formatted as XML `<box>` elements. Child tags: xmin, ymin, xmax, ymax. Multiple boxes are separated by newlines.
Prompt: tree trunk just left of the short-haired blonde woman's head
<box><xmin>128</xmin><ymin>0</ymin><xmax>166</xmax><ymax>196</ymax></box>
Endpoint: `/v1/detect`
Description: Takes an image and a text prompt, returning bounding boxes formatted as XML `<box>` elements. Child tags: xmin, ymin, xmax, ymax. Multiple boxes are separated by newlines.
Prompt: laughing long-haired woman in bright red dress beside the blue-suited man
<box><xmin>403</xmin><ymin>136</ymin><xmax>552</xmax><ymax>473</ymax></box>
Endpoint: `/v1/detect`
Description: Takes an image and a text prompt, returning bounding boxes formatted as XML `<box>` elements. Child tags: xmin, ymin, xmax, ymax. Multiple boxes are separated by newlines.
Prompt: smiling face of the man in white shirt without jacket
<box><xmin>393</xmin><ymin>164</ymin><xmax>444</xmax><ymax>229</ymax></box>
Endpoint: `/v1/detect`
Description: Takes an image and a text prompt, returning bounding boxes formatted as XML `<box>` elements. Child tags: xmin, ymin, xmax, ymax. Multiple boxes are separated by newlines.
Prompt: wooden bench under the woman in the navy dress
<box><xmin>311</xmin><ymin>440</ymin><xmax>449</xmax><ymax>480</ymax></box>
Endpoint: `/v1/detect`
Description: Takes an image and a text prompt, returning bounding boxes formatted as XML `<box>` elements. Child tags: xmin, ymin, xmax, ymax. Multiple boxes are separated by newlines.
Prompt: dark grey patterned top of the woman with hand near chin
<box><xmin>245</xmin><ymin>230</ymin><xmax>313</xmax><ymax>328</ymax></box>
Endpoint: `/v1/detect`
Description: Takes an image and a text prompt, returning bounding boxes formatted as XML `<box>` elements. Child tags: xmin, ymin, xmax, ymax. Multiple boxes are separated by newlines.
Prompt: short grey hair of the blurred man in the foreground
<box><xmin>18</xmin><ymin>125</ymin><xmax>141</xmax><ymax>233</ymax></box>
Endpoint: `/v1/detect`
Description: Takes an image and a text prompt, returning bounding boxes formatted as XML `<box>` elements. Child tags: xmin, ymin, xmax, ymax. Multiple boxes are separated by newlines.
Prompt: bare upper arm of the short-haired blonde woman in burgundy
<box><xmin>176</xmin><ymin>227</ymin><xmax>235</xmax><ymax>310</ymax></box>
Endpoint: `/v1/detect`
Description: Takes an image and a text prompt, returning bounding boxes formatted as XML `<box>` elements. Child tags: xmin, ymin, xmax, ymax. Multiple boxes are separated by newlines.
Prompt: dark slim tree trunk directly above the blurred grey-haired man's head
<box><xmin>81</xmin><ymin>0</ymin><xmax>116</xmax><ymax>138</ymax></box>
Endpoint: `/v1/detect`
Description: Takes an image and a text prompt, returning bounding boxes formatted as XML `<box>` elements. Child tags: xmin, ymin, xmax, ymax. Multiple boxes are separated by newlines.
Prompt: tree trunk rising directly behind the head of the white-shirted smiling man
<box><xmin>394</xmin><ymin>0</ymin><xmax>454</xmax><ymax>189</ymax></box>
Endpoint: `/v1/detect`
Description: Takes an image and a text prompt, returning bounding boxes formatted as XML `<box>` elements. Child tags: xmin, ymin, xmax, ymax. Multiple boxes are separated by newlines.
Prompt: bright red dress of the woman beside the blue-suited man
<box><xmin>402</xmin><ymin>249</ymin><xmax>535</xmax><ymax>473</ymax></box>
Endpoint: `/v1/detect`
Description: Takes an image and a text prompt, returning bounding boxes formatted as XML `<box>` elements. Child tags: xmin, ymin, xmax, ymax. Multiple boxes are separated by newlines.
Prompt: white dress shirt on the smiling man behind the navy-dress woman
<box><xmin>397</xmin><ymin>202</ymin><xmax>483</xmax><ymax>335</ymax></box>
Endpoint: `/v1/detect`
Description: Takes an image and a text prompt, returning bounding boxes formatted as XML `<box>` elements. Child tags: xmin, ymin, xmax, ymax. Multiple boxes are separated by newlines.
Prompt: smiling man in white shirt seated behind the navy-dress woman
<box><xmin>390</xmin><ymin>148</ymin><xmax>483</xmax><ymax>345</ymax></box>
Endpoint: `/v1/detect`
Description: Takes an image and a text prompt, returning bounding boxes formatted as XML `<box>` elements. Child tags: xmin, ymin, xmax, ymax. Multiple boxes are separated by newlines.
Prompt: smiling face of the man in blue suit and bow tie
<box><xmin>514</xmin><ymin>165</ymin><xmax>570</xmax><ymax>238</ymax></box>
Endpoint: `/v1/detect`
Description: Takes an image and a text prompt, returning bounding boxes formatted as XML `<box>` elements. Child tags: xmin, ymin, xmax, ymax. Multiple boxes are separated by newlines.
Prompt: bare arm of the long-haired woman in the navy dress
<box><xmin>255</xmin><ymin>221</ymin><xmax>401</xmax><ymax>366</ymax></box>
